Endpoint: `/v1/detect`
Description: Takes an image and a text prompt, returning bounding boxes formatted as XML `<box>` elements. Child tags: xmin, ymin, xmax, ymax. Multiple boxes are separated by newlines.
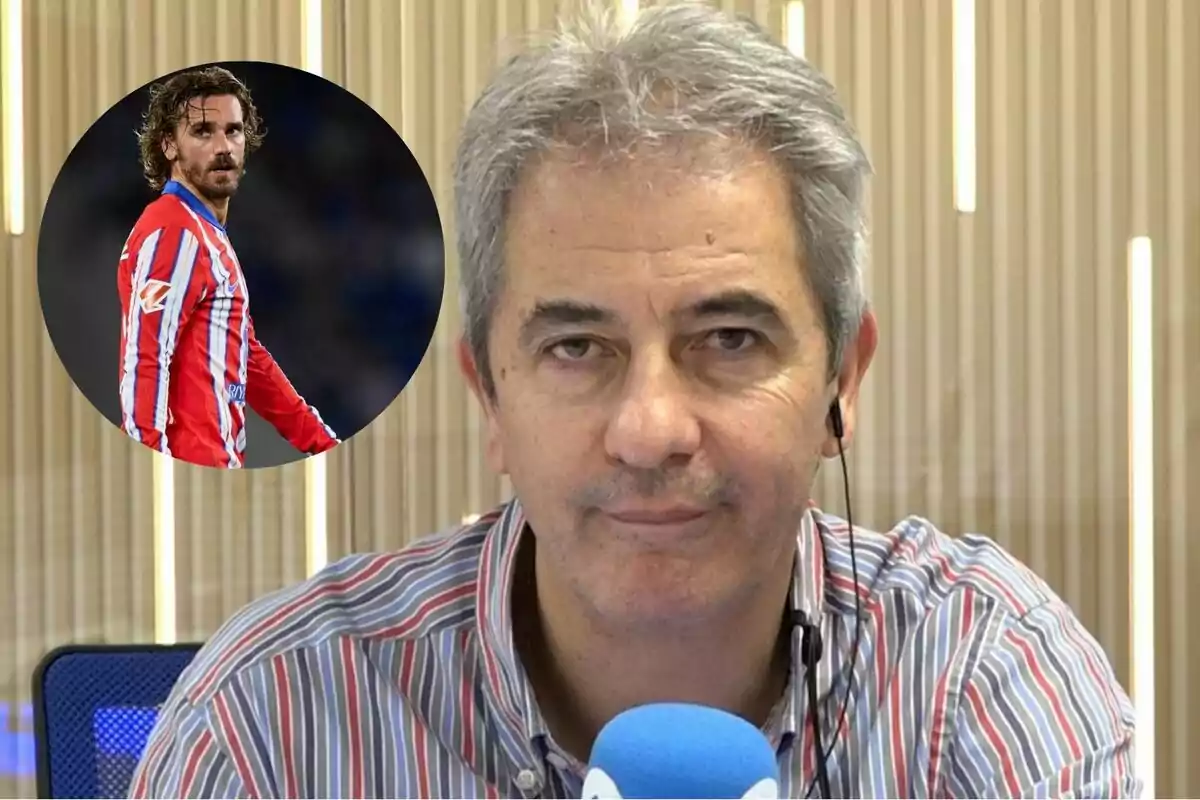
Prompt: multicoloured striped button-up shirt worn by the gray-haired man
<box><xmin>131</xmin><ymin>501</ymin><xmax>1140</xmax><ymax>798</ymax></box>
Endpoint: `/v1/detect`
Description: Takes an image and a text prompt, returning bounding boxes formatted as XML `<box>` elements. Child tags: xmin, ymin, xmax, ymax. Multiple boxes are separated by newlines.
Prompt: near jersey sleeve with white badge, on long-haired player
<box><xmin>118</xmin><ymin>225</ymin><xmax>211</xmax><ymax>455</ymax></box>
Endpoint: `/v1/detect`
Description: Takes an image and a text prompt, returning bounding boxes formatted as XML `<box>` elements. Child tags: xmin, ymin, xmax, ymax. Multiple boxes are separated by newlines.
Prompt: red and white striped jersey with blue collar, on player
<box><xmin>118</xmin><ymin>181</ymin><xmax>338</xmax><ymax>469</ymax></box>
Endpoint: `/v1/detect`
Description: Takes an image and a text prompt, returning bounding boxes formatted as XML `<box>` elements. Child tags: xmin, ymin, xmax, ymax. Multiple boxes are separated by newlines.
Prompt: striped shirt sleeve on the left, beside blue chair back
<box><xmin>130</xmin><ymin>698</ymin><xmax>250</xmax><ymax>800</ymax></box>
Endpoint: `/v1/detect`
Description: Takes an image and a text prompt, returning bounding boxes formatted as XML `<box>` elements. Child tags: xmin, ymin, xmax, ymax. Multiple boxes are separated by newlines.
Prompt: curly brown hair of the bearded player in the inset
<box><xmin>138</xmin><ymin>66</ymin><xmax>266</xmax><ymax>192</ymax></box>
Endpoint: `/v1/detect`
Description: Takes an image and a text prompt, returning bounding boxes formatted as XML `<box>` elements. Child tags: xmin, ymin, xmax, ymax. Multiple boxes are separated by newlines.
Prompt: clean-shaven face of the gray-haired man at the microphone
<box><xmin>468</xmin><ymin>145</ymin><xmax>873</xmax><ymax>625</ymax></box>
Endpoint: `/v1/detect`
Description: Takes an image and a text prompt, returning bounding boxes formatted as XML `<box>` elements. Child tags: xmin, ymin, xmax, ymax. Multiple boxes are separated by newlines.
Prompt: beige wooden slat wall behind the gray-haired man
<box><xmin>0</xmin><ymin>0</ymin><xmax>1200</xmax><ymax>796</ymax></box>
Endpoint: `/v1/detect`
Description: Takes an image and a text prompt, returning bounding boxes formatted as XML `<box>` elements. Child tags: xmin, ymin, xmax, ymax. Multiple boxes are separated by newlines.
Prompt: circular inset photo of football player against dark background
<box><xmin>37</xmin><ymin>61</ymin><xmax>445</xmax><ymax>469</ymax></box>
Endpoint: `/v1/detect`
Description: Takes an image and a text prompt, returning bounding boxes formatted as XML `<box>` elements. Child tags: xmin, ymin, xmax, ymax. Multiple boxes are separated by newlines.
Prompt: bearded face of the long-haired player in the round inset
<box><xmin>164</xmin><ymin>95</ymin><xmax>246</xmax><ymax>200</ymax></box>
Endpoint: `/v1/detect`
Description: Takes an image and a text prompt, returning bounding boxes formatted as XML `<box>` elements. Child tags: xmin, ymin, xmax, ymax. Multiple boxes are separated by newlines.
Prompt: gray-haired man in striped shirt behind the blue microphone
<box><xmin>132</xmin><ymin>5</ymin><xmax>1139</xmax><ymax>798</ymax></box>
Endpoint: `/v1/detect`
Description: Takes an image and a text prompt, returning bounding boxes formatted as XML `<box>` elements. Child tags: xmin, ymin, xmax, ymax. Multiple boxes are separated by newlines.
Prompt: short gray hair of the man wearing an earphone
<box><xmin>455</xmin><ymin>2</ymin><xmax>871</xmax><ymax>397</ymax></box>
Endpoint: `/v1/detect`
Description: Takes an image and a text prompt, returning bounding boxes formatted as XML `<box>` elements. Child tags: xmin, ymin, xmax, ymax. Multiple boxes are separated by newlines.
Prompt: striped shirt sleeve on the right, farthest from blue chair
<box><xmin>942</xmin><ymin>601</ymin><xmax>1142</xmax><ymax>798</ymax></box>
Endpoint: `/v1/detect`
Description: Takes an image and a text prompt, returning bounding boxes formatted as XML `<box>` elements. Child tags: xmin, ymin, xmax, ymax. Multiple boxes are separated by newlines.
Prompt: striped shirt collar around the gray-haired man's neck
<box><xmin>475</xmin><ymin>500</ymin><xmax>854</xmax><ymax>763</ymax></box>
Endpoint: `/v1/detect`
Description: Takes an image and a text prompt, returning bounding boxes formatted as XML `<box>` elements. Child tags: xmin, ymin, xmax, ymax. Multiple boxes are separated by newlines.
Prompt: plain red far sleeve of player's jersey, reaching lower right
<box><xmin>246</xmin><ymin>323</ymin><xmax>340</xmax><ymax>456</ymax></box>
